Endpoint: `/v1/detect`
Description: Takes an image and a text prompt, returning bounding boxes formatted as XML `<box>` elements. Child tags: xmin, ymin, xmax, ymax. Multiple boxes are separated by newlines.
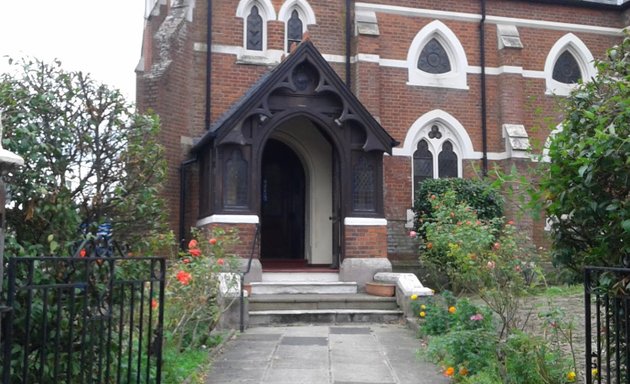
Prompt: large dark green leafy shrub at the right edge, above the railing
<box><xmin>541</xmin><ymin>34</ymin><xmax>630</xmax><ymax>272</ymax></box>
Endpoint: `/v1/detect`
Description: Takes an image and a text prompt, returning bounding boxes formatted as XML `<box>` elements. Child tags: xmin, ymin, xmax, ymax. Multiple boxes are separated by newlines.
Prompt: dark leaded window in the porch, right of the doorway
<box><xmin>352</xmin><ymin>153</ymin><xmax>376</xmax><ymax>211</ymax></box>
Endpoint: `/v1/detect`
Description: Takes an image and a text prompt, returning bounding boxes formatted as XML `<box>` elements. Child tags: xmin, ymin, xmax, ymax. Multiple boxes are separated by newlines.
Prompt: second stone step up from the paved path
<box><xmin>249</xmin><ymin>293</ymin><xmax>398</xmax><ymax>311</ymax></box>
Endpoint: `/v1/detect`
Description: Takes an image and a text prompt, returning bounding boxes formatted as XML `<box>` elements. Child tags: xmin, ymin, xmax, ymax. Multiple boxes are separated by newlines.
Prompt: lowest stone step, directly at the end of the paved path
<box><xmin>249</xmin><ymin>309</ymin><xmax>403</xmax><ymax>327</ymax></box>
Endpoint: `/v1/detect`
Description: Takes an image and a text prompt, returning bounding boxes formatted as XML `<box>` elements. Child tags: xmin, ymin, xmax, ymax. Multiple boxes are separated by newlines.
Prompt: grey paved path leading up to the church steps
<box><xmin>206</xmin><ymin>324</ymin><xmax>449</xmax><ymax>384</ymax></box>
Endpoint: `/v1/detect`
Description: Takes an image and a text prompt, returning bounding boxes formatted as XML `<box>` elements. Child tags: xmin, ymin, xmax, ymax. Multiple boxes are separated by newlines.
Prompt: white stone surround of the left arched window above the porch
<box><xmin>236</xmin><ymin>0</ymin><xmax>276</xmax><ymax>64</ymax></box>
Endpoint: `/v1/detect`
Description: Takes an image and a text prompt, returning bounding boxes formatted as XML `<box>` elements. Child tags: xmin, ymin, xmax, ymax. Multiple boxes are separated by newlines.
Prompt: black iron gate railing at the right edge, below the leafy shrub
<box><xmin>584</xmin><ymin>267</ymin><xmax>630</xmax><ymax>384</ymax></box>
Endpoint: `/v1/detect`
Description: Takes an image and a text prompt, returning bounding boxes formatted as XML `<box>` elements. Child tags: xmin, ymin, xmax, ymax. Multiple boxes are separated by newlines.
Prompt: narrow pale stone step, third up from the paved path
<box><xmin>251</xmin><ymin>281</ymin><xmax>357</xmax><ymax>297</ymax></box>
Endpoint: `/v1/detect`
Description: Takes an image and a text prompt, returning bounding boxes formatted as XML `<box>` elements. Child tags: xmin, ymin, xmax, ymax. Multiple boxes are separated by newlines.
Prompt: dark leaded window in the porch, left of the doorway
<box><xmin>223</xmin><ymin>148</ymin><xmax>248</xmax><ymax>207</ymax></box>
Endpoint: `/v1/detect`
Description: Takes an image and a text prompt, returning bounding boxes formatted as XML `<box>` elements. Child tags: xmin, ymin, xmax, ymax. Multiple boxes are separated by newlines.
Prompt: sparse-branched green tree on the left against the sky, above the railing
<box><xmin>0</xmin><ymin>60</ymin><xmax>166</xmax><ymax>256</ymax></box>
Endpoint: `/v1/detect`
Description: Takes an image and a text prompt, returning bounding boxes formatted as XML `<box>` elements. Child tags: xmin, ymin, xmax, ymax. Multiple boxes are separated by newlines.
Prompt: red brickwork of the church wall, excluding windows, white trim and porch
<box><xmin>138</xmin><ymin>0</ymin><xmax>630</xmax><ymax>257</ymax></box>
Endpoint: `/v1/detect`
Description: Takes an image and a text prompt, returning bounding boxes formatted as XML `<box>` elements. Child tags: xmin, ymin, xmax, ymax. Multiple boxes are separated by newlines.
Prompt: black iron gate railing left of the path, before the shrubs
<box><xmin>0</xmin><ymin>257</ymin><xmax>165</xmax><ymax>384</ymax></box>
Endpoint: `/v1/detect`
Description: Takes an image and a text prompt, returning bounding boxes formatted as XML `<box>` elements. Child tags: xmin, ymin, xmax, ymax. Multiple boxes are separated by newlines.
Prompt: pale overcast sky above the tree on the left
<box><xmin>0</xmin><ymin>0</ymin><xmax>145</xmax><ymax>101</ymax></box>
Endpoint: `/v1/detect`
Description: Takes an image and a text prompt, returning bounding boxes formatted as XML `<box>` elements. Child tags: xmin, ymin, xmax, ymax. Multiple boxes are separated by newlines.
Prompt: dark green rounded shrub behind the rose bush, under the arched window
<box><xmin>414</xmin><ymin>179</ymin><xmax>503</xmax><ymax>233</ymax></box>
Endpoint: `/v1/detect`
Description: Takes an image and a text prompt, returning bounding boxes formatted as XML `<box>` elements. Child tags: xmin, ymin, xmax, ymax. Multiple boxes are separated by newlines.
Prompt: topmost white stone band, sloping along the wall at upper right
<box><xmin>355</xmin><ymin>2</ymin><xmax>623</xmax><ymax>36</ymax></box>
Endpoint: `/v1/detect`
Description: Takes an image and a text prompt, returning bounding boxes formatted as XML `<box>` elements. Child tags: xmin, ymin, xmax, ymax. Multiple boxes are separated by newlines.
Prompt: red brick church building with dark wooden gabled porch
<box><xmin>137</xmin><ymin>0</ymin><xmax>630</xmax><ymax>282</ymax></box>
